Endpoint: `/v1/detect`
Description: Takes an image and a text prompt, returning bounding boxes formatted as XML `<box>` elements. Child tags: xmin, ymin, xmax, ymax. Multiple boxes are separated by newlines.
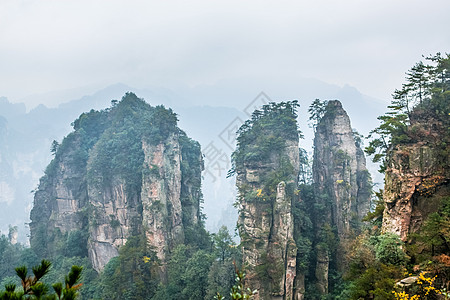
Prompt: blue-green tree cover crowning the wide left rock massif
<box><xmin>45</xmin><ymin>93</ymin><xmax>181</xmax><ymax>199</ymax></box>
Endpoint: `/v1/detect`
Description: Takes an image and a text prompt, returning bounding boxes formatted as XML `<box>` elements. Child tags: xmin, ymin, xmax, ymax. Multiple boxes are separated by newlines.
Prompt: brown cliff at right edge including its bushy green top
<box><xmin>382</xmin><ymin>110</ymin><xmax>450</xmax><ymax>241</ymax></box>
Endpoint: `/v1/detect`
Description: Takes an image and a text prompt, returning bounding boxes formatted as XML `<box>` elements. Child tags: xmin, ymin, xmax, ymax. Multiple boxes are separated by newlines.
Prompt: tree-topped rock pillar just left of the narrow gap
<box><xmin>233</xmin><ymin>103</ymin><xmax>299</xmax><ymax>299</ymax></box>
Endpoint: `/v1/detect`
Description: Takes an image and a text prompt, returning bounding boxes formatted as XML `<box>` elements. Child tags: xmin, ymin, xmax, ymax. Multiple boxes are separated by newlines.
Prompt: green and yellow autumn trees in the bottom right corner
<box><xmin>339</xmin><ymin>197</ymin><xmax>450</xmax><ymax>300</ymax></box>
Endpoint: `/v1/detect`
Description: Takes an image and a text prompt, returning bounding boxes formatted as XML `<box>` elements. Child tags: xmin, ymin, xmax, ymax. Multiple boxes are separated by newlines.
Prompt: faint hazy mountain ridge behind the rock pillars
<box><xmin>0</xmin><ymin>79</ymin><xmax>385</xmax><ymax>241</ymax></box>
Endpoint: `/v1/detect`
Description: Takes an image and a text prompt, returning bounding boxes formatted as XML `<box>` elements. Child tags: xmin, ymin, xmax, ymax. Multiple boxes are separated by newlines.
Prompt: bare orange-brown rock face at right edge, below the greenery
<box><xmin>382</xmin><ymin>143</ymin><xmax>450</xmax><ymax>241</ymax></box>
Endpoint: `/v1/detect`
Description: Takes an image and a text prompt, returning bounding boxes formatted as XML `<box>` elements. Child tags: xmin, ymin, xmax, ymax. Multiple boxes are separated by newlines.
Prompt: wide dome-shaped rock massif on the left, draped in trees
<box><xmin>30</xmin><ymin>93</ymin><xmax>203</xmax><ymax>275</ymax></box>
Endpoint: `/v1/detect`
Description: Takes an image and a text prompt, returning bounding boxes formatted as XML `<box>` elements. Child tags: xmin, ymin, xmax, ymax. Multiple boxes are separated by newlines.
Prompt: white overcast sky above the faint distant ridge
<box><xmin>0</xmin><ymin>0</ymin><xmax>450</xmax><ymax>106</ymax></box>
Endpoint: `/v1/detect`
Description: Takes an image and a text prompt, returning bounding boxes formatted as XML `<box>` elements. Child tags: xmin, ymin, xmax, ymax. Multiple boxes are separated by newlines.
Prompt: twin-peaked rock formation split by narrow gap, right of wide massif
<box><xmin>232</xmin><ymin>101</ymin><xmax>372</xmax><ymax>300</ymax></box>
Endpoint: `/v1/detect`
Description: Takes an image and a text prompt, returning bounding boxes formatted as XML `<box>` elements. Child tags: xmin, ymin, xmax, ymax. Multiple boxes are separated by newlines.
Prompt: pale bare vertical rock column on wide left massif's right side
<box><xmin>141</xmin><ymin>136</ymin><xmax>184</xmax><ymax>278</ymax></box>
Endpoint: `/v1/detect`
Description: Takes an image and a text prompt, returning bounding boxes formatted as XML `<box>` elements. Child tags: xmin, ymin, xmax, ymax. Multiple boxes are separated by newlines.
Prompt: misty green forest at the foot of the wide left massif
<box><xmin>0</xmin><ymin>227</ymin><xmax>243</xmax><ymax>300</ymax></box>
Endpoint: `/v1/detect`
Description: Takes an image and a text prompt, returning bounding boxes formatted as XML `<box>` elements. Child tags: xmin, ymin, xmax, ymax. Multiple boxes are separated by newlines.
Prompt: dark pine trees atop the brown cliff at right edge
<box><xmin>365</xmin><ymin>53</ymin><xmax>450</xmax><ymax>172</ymax></box>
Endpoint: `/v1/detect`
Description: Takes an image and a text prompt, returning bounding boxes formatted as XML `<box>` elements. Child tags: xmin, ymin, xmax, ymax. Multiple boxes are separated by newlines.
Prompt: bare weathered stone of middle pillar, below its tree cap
<box><xmin>236</xmin><ymin>133</ymin><xmax>299</xmax><ymax>300</ymax></box>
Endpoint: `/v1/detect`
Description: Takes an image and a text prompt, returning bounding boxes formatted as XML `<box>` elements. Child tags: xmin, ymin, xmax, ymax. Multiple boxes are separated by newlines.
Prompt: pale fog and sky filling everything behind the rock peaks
<box><xmin>0</xmin><ymin>0</ymin><xmax>450</xmax><ymax>237</ymax></box>
